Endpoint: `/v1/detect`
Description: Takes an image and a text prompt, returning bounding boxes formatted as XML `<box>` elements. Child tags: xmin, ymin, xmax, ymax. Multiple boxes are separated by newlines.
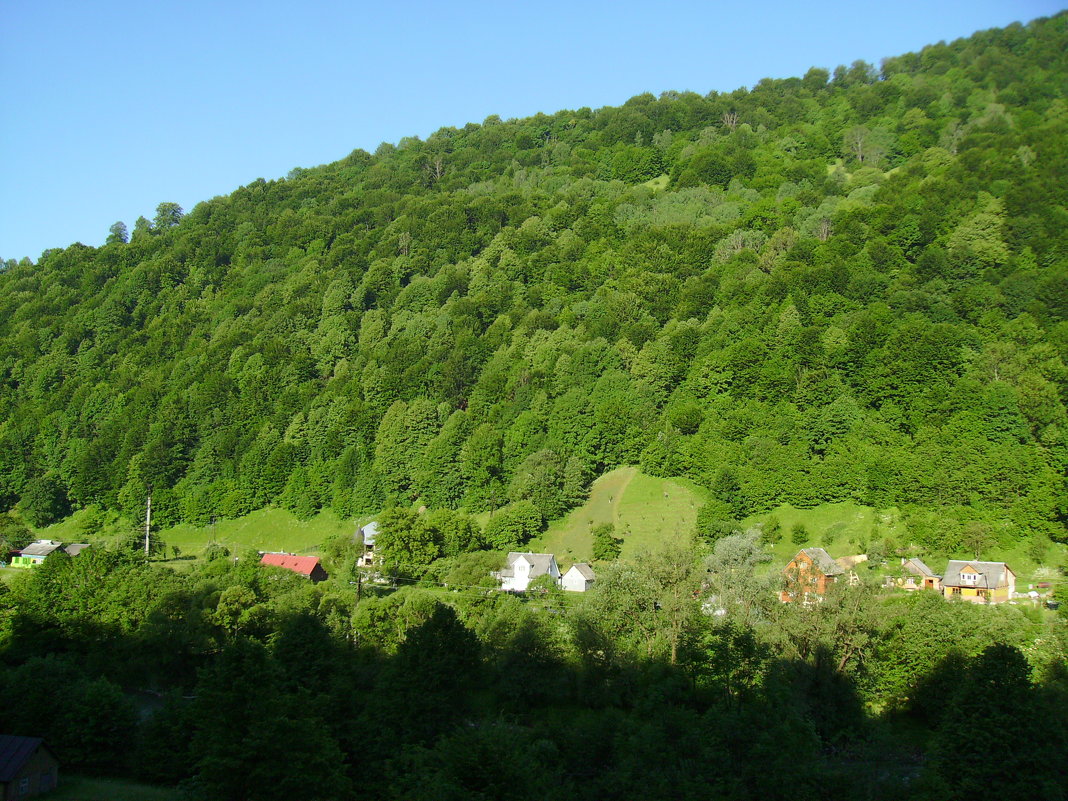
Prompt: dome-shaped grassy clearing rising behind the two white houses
<box><xmin>528</xmin><ymin>467</ymin><xmax>704</xmax><ymax>569</ymax></box>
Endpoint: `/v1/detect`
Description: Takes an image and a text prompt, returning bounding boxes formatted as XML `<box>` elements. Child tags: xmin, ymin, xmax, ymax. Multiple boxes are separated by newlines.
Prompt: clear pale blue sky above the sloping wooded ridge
<box><xmin>0</xmin><ymin>0</ymin><xmax>1065</xmax><ymax>260</ymax></box>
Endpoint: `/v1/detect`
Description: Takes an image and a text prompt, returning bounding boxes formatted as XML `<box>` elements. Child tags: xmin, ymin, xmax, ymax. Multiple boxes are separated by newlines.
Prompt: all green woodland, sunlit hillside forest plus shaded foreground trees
<box><xmin>0</xmin><ymin>14</ymin><xmax>1068</xmax><ymax>801</ymax></box>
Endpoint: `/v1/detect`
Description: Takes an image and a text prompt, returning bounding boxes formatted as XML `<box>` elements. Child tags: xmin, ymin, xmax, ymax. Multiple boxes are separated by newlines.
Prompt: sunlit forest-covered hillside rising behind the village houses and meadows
<box><xmin>0</xmin><ymin>14</ymin><xmax>1068</xmax><ymax>552</ymax></box>
